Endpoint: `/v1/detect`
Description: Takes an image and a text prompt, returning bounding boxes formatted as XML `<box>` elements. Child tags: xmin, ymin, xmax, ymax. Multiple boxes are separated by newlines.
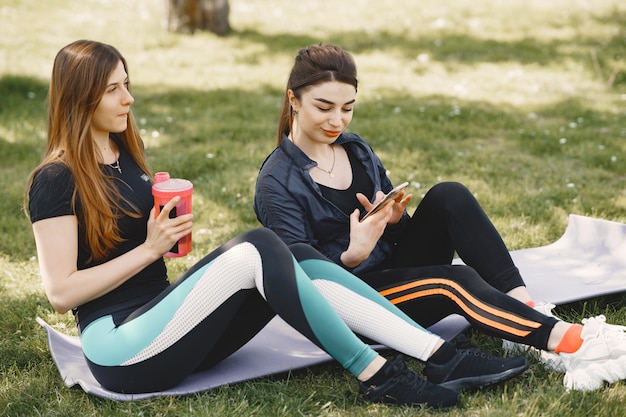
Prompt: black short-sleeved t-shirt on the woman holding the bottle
<box><xmin>29</xmin><ymin>137</ymin><xmax>169</xmax><ymax>329</ymax></box>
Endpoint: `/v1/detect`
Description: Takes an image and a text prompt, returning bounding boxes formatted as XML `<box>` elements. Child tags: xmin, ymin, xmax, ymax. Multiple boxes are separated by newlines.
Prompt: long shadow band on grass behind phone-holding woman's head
<box><xmin>223</xmin><ymin>6</ymin><xmax>626</xmax><ymax>87</ymax></box>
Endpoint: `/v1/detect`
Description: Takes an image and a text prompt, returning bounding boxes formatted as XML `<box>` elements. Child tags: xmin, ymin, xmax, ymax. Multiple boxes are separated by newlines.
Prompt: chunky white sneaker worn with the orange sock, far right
<box><xmin>559</xmin><ymin>315</ymin><xmax>626</xmax><ymax>391</ymax></box>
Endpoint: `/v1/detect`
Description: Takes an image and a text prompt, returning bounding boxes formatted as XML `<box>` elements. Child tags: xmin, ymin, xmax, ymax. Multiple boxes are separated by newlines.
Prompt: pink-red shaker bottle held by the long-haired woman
<box><xmin>152</xmin><ymin>172</ymin><xmax>193</xmax><ymax>258</ymax></box>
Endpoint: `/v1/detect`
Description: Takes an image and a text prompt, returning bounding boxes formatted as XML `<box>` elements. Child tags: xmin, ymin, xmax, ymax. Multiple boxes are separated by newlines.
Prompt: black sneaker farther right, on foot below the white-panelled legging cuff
<box><xmin>424</xmin><ymin>349</ymin><xmax>530</xmax><ymax>391</ymax></box>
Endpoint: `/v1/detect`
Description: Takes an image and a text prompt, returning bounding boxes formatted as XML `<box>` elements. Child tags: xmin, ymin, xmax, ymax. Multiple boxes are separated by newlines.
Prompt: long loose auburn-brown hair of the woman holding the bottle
<box><xmin>24</xmin><ymin>40</ymin><xmax>151</xmax><ymax>259</ymax></box>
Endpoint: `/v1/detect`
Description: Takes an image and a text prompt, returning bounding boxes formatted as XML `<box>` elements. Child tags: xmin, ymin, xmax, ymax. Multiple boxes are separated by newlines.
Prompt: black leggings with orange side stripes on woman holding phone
<box><xmin>361</xmin><ymin>182</ymin><xmax>557</xmax><ymax>349</ymax></box>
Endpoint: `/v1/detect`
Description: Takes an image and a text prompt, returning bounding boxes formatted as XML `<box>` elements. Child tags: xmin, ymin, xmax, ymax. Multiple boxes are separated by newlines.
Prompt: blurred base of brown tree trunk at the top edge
<box><xmin>166</xmin><ymin>0</ymin><xmax>230</xmax><ymax>36</ymax></box>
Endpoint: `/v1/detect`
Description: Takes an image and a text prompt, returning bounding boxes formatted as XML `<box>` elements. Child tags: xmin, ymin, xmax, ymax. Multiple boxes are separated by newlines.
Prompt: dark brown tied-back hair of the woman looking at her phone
<box><xmin>277</xmin><ymin>44</ymin><xmax>358</xmax><ymax>145</ymax></box>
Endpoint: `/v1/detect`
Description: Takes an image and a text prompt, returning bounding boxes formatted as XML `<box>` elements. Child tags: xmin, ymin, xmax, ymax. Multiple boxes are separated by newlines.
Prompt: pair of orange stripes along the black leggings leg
<box><xmin>380</xmin><ymin>278</ymin><xmax>541</xmax><ymax>337</ymax></box>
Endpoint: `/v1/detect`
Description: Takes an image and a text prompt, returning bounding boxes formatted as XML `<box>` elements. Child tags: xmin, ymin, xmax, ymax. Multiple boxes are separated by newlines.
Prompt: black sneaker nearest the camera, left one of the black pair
<box><xmin>359</xmin><ymin>355</ymin><xmax>460</xmax><ymax>408</ymax></box>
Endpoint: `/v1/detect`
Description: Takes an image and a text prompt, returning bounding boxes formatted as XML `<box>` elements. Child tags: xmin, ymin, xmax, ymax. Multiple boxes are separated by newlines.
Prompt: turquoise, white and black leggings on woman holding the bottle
<box><xmin>81</xmin><ymin>229</ymin><xmax>439</xmax><ymax>393</ymax></box>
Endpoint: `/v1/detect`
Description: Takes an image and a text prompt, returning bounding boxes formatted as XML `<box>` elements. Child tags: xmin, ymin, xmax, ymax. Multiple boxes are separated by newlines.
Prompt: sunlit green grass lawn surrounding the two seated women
<box><xmin>0</xmin><ymin>0</ymin><xmax>626</xmax><ymax>416</ymax></box>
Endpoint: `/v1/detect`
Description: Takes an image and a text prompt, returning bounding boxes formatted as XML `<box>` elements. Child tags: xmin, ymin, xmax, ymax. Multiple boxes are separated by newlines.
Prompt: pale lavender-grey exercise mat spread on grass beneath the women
<box><xmin>37</xmin><ymin>215</ymin><xmax>626</xmax><ymax>401</ymax></box>
